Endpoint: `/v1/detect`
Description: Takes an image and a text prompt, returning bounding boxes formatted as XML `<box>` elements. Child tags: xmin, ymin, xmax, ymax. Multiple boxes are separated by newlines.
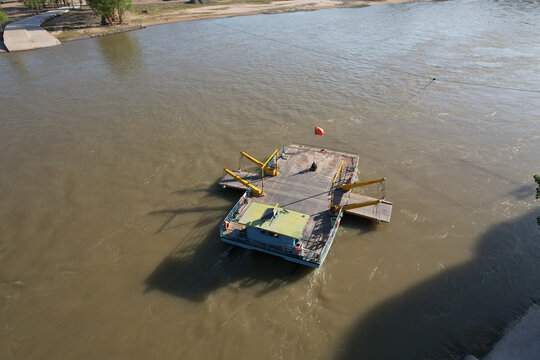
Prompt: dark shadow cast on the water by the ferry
<box><xmin>145</xmin><ymin>189</ymin><xmax>312</xmax><ymax>301</ymax></box>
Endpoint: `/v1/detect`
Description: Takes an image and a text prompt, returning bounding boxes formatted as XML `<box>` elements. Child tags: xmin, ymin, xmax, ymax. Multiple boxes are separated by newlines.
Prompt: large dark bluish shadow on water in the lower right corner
<box><xmin>336</xmin><ymin>211</ymin><xmax>540</xmax><ymax>359</ymax></box>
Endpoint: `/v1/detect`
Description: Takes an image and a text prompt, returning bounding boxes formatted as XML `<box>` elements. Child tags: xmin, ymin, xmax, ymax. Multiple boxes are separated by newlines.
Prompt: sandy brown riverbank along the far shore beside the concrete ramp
<box><xmin>43</xmin><ymin>0</ymin><xmax>414</xmax><ymax>41</ymax></box>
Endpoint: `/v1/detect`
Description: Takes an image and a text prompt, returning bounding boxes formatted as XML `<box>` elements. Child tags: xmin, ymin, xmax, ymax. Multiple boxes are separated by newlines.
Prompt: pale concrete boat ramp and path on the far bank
<box><xmin>4</xmin><ymin>6</ymin><xmax>72</xmax><ymax>52</ymax></box>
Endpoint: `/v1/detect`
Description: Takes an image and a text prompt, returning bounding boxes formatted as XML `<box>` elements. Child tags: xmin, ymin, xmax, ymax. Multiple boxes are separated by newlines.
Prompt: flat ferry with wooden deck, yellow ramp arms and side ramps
<box><xmin>219</xmin><ymin>144</ymin><xmax>392</xmax><ymax>267</ymax></box>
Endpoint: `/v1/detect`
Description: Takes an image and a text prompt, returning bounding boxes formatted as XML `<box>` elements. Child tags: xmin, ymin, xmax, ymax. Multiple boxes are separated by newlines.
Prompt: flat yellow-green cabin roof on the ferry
<box><xmin>238</xmin><ymin>202</ymin><xmax>309</xmax><ymax>239</ymax></box>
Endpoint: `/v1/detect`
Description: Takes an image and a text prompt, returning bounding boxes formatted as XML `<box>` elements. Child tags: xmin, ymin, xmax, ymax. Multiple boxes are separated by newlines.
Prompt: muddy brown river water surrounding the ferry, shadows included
<box><xmin>0</xmin><ymin>0</ymin><xmax>540</xmax><ymax>360</ymax></box>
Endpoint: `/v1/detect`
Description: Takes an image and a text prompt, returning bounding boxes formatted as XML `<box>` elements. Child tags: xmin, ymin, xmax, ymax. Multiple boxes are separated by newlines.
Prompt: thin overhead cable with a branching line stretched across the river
<box><xmin>214</xmin><ymin>22</ymin><xmax>540</xmax><ymax>94</ymax></box>
